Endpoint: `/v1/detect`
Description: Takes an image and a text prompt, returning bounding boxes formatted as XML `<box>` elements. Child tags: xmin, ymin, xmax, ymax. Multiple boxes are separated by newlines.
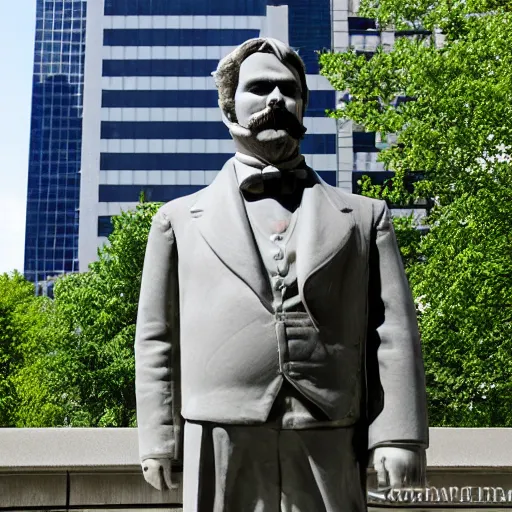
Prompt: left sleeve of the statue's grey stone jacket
<box><xmin>135</xmin><ymin>209</ymin><xmax>181</xmax><ymax>460</ymax></box>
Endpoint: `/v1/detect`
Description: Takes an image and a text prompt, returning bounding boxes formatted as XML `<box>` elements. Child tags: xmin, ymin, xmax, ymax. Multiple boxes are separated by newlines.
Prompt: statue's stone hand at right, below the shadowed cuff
<box><xmin>373</xmin><ymin>446</ymin><xmax>426</xmax><ymax>488</ymax></box>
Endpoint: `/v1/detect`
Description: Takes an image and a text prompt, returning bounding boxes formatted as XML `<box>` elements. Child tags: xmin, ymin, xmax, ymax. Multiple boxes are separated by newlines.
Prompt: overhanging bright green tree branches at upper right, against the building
<box><xmin>320</xmin><ymin>5</ymin><xmax>512</xmax><ymax>204</ymax></box>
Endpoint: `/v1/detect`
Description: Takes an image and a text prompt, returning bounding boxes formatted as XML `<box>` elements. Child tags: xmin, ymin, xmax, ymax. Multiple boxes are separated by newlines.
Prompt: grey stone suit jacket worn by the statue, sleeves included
<box><xmin>135</xmin><ymin>159</ymin><xmax>428</xmax><ymax>460</ymax></box>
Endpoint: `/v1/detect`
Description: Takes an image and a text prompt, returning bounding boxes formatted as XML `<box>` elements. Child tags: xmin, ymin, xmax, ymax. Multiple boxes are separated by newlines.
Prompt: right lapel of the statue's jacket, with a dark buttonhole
<box><xmin>297</xmin><ymin>174</ymin><xmax>354</xmax><ymax>312</ymax></box>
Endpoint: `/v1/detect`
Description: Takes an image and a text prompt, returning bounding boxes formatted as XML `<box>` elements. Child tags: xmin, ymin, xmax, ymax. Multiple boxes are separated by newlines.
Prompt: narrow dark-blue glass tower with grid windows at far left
<box><xmin>25</xmin><ymin>0</ymin><xmax>86</xmax><ymax>282</ymax></box>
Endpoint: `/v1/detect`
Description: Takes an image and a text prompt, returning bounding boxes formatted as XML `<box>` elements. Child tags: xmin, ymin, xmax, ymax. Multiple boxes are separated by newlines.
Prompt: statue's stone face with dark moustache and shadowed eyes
<box><xmin>235</xmin><ymin>53</ymin><xmax>303</xmax><ymax>141</ymax></box>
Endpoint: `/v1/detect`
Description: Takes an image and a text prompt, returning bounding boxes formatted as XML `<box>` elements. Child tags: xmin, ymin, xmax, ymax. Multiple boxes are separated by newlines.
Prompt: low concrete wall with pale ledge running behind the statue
<box><xmin>0</xmin><ymin>428</ymin><xmax>512</xmax><ymax>511</ymax></box>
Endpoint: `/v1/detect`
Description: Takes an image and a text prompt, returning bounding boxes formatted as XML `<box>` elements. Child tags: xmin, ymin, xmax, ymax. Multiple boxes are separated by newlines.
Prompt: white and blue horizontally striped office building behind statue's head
<box><xmin>79</xmin><ymin>0</ymin><xmax>338</xmax><ymax>270</ymax></box>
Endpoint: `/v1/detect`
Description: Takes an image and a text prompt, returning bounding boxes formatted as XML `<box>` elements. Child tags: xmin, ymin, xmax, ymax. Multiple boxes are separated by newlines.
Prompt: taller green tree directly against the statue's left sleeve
<box><xmin>49</xmin><ymin>203</ymin><xmax>159</xmax><ymax>427</ymax></box>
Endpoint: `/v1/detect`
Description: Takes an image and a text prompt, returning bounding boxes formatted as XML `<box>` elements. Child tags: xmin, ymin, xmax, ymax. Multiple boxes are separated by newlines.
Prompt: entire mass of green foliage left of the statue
<box><xmin>0</xmin><ymin>203</ymin><xmax>159</xmax><ymax>427</ymax></box>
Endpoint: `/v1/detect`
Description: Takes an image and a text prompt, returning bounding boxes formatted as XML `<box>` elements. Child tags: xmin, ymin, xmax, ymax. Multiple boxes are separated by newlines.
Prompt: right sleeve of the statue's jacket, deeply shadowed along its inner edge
<box><xmin>367</xmin><ymin>201</ymin><xmax>428</xmax><ymax>449</ymax></box>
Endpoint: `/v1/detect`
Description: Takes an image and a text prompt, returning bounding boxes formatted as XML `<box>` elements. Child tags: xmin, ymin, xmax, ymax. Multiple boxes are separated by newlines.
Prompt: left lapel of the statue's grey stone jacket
<box><xmin>190</xmin><ymin>159</ymin><xmax>272</xmax><ymax>307</ymax></box>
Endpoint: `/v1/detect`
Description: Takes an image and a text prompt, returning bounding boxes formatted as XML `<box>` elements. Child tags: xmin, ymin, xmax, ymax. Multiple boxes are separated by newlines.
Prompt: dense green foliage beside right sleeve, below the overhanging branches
<box><xmin>411</xmin><ymin>180</ymin><xmax>512</xmax><ymax>427</ymax></box>
